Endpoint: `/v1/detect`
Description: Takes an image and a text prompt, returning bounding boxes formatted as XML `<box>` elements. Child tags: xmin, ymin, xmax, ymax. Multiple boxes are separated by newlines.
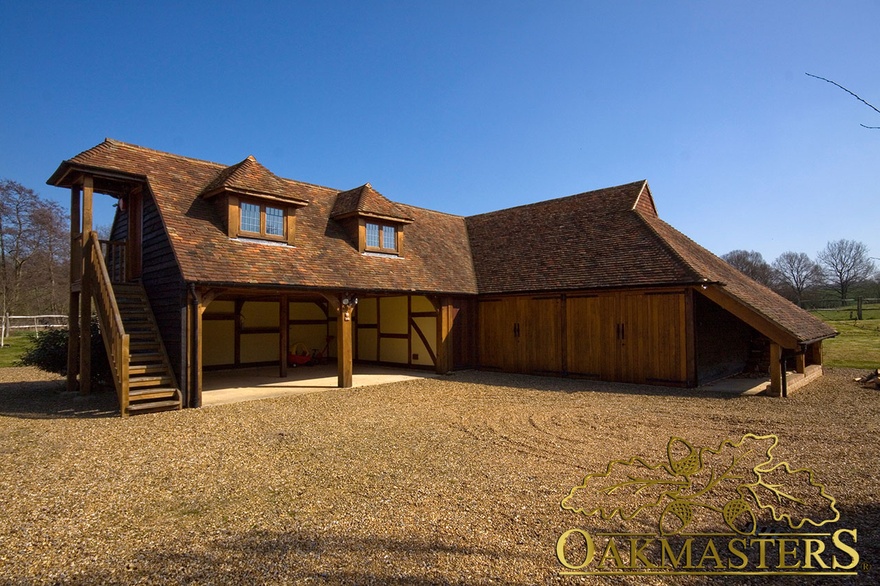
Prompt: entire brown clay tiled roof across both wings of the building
<box><xmin>50</xmin><ymin>139</ymin><xmax>834</xmax><ymax>341</ymax></box>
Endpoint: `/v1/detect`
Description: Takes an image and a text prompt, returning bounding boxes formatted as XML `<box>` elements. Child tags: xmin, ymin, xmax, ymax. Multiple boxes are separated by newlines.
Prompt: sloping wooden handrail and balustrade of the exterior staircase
<box><xmin>83</xmin><ymin>232</ymin><xmax>130</xmax><ymax>417</ymax></box>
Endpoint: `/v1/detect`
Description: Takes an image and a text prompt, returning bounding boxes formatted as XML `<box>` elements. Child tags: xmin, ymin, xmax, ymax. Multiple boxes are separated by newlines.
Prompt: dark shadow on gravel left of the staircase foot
<box><xmin>0</xmin><ymin>381</ymin><xmax>119</xmax><ymax>419</ymax></box>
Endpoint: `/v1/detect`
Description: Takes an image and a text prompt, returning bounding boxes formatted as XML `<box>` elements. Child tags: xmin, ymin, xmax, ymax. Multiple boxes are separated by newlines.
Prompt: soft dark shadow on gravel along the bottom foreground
<box><xmin>56</xmin><ymin>530</ymin><xmax>554</xmax><ymax>586</ymax></box>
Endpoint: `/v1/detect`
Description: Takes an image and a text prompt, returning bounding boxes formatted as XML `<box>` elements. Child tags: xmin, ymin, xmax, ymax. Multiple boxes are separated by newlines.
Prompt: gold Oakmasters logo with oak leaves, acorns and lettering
<box><xmin>556</xmin><ymin>433</ymin><xmax>859</xmax><ymax>575</ymax></box>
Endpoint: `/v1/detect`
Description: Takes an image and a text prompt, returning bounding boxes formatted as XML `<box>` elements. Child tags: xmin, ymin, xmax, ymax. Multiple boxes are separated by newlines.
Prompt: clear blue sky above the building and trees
<box><xmin>0</xmin><ymin>0</ymin><xmax>880</xmax><ymax>261</ymax></box>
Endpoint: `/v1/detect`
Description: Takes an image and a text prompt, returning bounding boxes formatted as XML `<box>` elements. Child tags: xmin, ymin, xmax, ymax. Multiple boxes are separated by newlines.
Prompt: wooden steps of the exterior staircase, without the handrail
<box><xmin>113</xmin><ymin>283</ymin><xmax>181</xmax><ymax>416</ymax></box>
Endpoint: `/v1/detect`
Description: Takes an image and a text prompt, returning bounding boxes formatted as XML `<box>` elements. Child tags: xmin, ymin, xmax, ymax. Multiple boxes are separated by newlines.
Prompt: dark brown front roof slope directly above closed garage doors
<box><xmin>467</xmin><ymin>181</ymin><xmax>697</xmax><ymax>293</ymax></box>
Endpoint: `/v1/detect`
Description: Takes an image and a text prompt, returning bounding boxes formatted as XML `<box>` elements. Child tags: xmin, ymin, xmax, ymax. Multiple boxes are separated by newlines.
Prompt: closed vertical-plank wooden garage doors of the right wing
<box><xmin>478</xmin><ymin>287</ymin><xmax>696</xmax><ymax>386</ymax></box>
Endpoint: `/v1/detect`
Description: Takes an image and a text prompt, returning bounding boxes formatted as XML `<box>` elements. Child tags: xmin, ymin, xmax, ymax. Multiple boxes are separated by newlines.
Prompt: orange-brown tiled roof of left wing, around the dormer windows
<box><xmin>49</xmin><ymin>139</ymin><xmax>477</xmax><ymax>294</ymax></box>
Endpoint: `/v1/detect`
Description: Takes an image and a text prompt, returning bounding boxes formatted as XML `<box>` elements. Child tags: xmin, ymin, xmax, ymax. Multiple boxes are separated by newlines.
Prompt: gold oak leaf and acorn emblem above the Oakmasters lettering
<box><xmin>562</xmin><ymin>433</ymin><xmax>840</xmax><ymax>535</ymax></box>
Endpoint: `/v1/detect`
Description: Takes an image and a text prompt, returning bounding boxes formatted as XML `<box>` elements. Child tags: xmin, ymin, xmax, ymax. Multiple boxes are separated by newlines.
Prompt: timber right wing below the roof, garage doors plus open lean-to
<box><xmin>476</xmin><ymin>286</ymin><xmax>822</xmax><ymax>396</ymax></box>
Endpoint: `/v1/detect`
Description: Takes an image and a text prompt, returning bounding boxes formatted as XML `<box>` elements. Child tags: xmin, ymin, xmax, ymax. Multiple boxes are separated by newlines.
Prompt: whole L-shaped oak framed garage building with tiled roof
<box><xmin>48</xmin><ymin>139</ymin><xmax>836</xmax><ymax>415</ymax></box>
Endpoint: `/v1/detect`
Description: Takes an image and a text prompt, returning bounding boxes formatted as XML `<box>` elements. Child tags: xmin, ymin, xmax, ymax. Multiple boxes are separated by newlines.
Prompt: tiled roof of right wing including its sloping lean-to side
<box><xmin>467</xmin><ymin>181</ymin><xmax>835</xmax><ymax>342</ymax></box>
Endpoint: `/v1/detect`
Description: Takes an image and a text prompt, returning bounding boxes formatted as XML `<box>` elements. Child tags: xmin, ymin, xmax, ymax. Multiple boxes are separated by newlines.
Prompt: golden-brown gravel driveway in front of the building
<box><xmin>0</xmin><ymin>368</ymin><xmax>880</xmax><ymax>584</ymax></box>
